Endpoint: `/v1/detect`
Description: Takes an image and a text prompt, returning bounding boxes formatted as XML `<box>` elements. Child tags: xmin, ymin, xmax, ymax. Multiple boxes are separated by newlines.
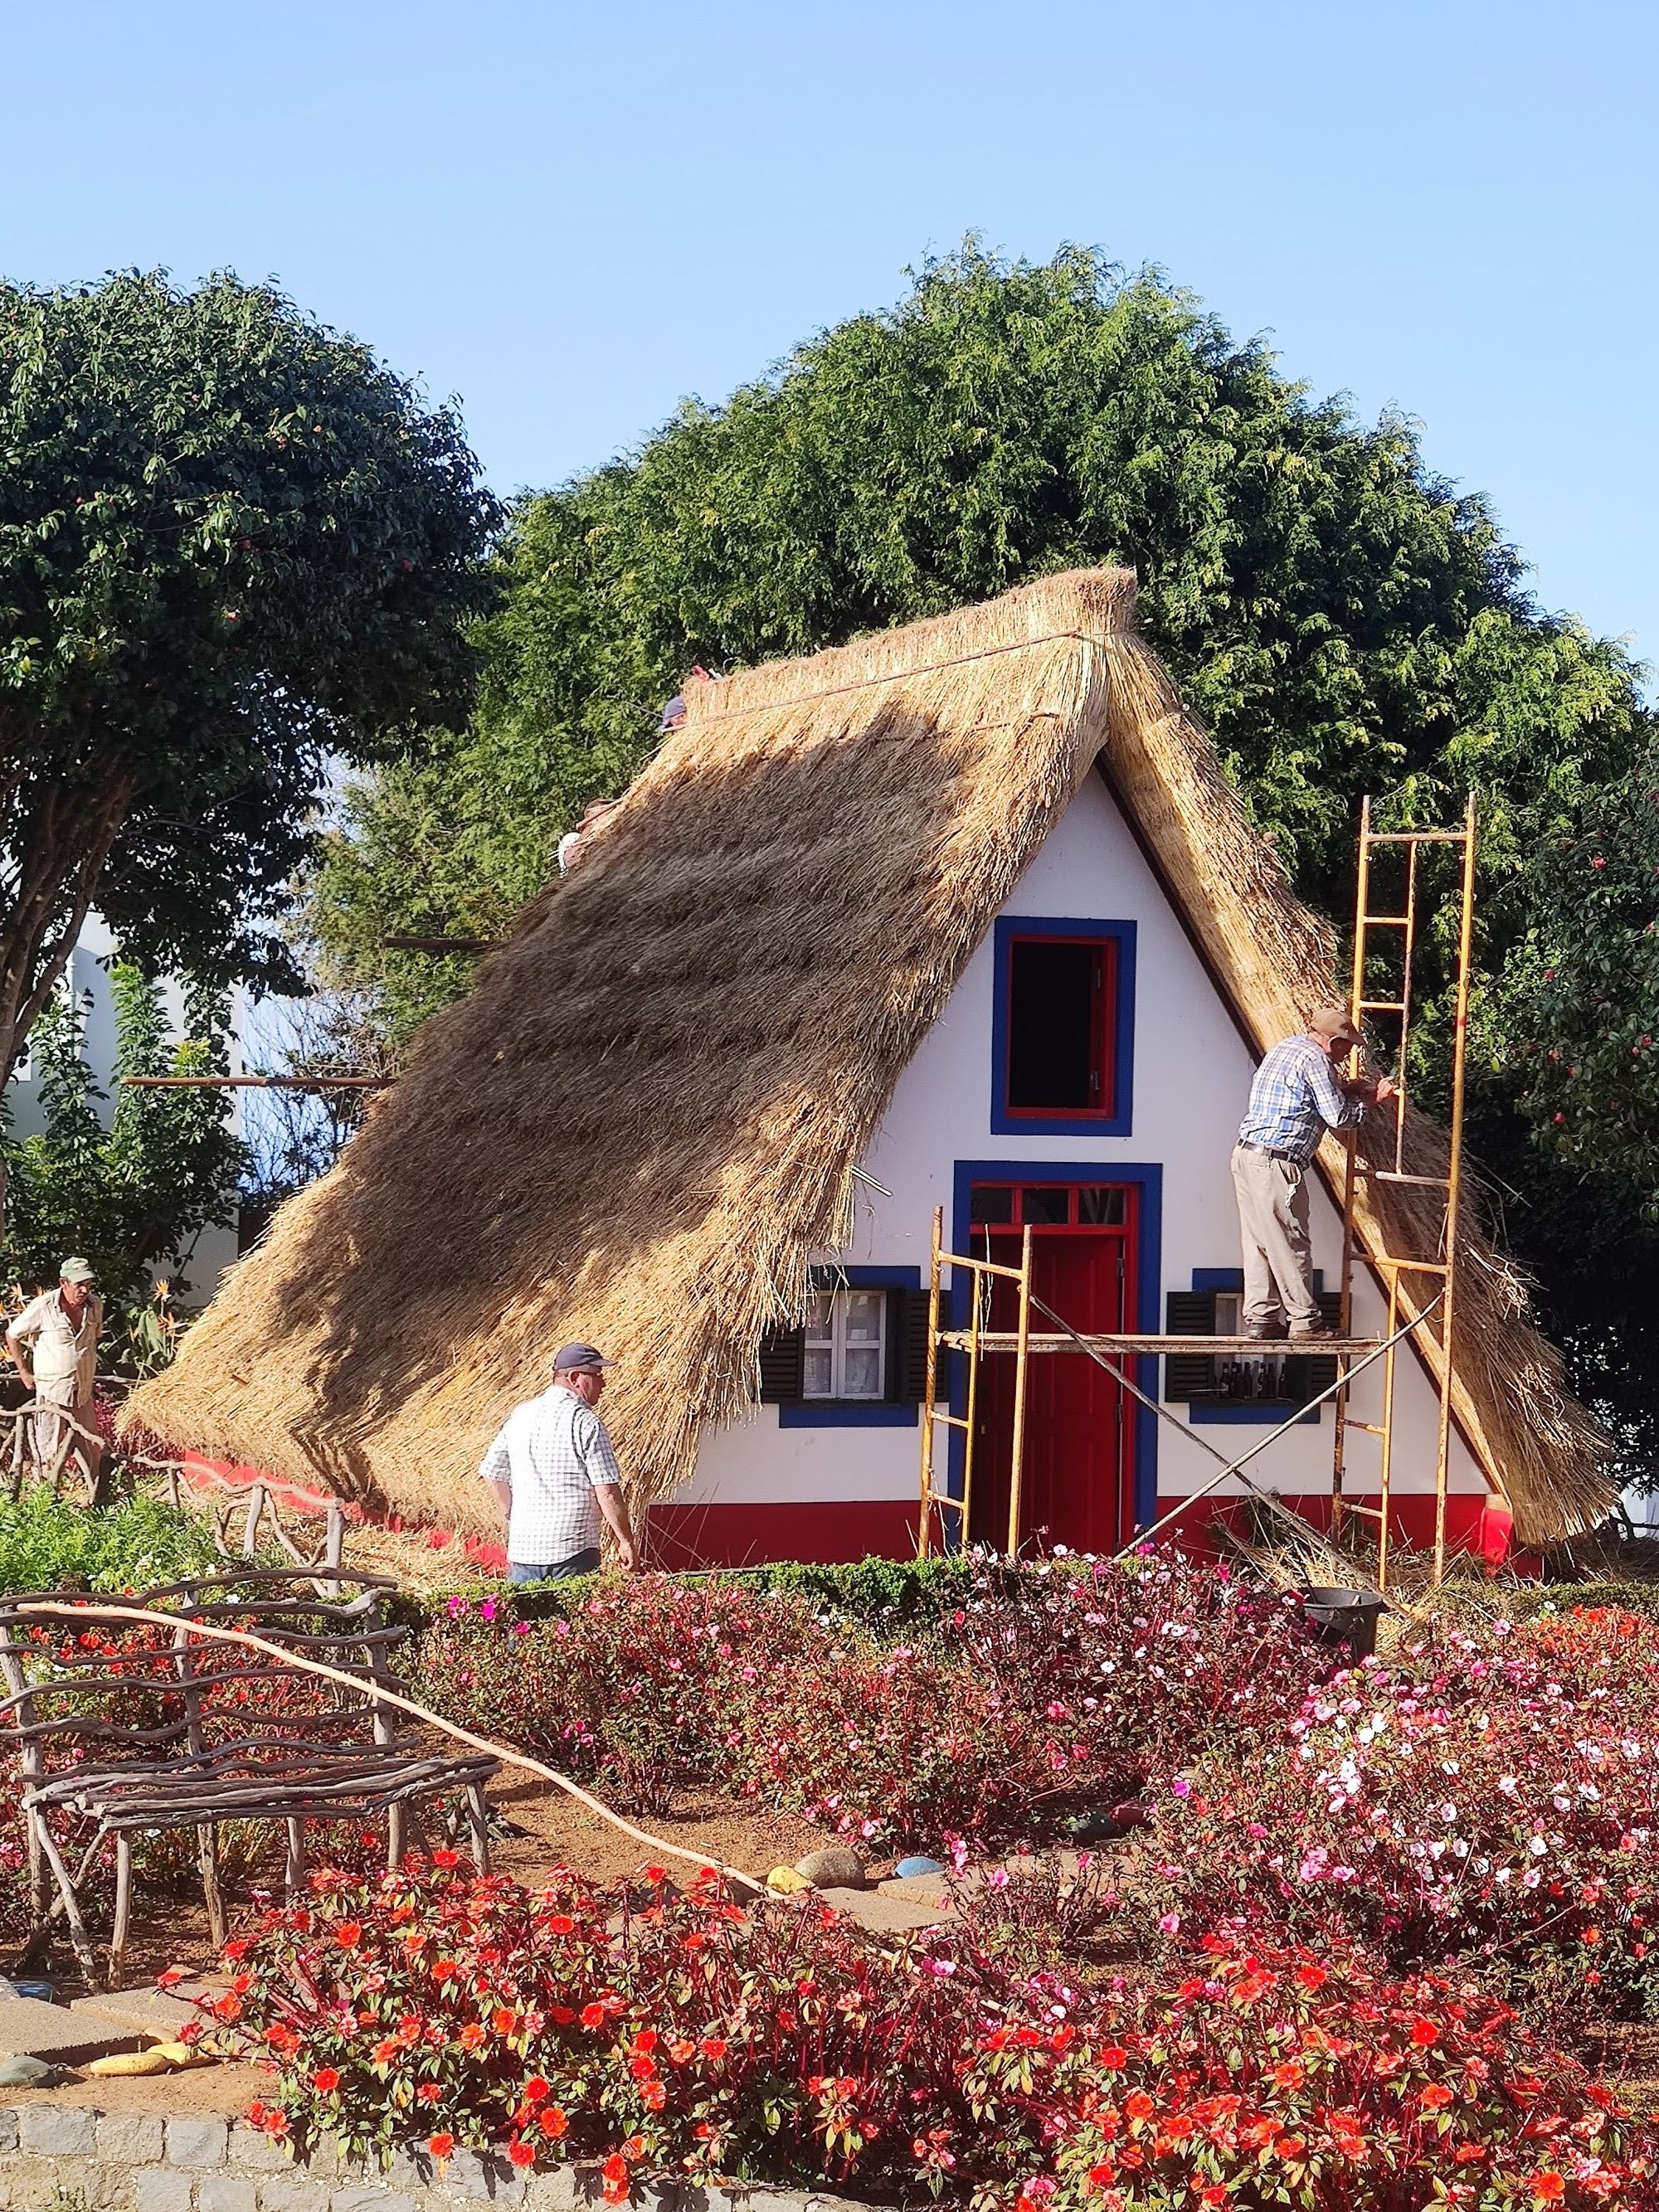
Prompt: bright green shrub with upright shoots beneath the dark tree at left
<box><xmin>0</xmin><ymin>960</ymin><xmax>243</xmax><ymax>1300</ymax></box>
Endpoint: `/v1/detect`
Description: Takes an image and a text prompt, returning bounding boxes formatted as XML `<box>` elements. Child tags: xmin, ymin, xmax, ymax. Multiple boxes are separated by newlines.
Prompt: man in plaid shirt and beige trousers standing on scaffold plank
<box><xmin>1232</xmin><ymin>1006</ymin><xmax>1394</xmax><ymax>1340</ymax></box>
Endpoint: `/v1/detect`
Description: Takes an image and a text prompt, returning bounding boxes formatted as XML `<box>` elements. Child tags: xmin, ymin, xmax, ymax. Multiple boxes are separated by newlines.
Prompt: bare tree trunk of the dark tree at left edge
<box><xmin>0</xmin><ymin>763</ymin><xmax>133</xmax><ymax>1239</ymax></box>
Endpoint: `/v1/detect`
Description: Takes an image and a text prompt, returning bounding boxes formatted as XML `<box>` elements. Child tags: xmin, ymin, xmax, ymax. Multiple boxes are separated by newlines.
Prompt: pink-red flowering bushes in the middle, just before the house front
<box><xmin>414</xmin><ymin>1555</ymin><xmax>1336</xmax><ymax>1850</ymax></box>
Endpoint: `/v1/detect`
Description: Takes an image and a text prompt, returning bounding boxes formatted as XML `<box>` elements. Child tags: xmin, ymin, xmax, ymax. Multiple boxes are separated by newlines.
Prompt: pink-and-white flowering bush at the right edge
<box><xmin>1159</xmin><ymin>1611</ymin><xmax>1659</xmax><ymax>2020</ymax></box>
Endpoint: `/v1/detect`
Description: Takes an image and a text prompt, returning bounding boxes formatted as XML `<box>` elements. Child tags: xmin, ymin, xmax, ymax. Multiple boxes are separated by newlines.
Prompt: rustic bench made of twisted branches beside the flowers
<box><xmin>0</xmin><ymin>1568</ymin><xmax>498</xmax><ymax>1982</ymax></box>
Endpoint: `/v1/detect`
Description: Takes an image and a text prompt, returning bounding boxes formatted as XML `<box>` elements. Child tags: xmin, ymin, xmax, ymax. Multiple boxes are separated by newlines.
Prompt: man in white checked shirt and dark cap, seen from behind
<box><xmin>478</xmin><ymin>1345</ymin><xmax>640</xmax><ymax>1582</ymax></box>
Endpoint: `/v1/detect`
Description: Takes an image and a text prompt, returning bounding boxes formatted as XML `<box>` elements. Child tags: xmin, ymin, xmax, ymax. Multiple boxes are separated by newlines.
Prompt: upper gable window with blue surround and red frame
<box><xmin>991</xmin><ymin>916</ymin><xmax>1135</xmax><ymax>1137</ymax></box>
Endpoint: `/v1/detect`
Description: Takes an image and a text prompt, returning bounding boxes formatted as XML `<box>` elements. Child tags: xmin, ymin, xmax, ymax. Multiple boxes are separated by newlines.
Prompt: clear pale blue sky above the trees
<box><xmin>0</xmin><ymin>0</ymin><xmax>1659</xmax><ymax>657</ymax></box>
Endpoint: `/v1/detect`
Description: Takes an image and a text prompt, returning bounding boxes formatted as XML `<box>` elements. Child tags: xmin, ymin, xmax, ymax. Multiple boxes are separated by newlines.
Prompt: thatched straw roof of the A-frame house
<box><xmin>130</xmin><ymin>571</ymin><xmax>1610</xmax><ymax>1539</ymax></box>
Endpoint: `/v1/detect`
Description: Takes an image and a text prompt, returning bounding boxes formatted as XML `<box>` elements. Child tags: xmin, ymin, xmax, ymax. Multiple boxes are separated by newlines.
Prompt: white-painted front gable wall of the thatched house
<box><xmin>674</xmin><ymin>776</ymin><xmax>1486</xmax><ymax>1557</ymax></box>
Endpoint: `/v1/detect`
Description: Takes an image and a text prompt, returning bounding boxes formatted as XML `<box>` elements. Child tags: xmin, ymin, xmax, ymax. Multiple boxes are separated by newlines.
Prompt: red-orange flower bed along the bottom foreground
<box><xmin>201</xmin><ymin>1854</ymin><xmax>1655</xmax><ymax>2212</ymax></box>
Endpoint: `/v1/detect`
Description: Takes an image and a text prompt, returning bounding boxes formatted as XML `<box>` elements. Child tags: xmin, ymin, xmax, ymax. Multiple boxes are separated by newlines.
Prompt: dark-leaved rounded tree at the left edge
<box><xmin>0</xmin><ymin>275</ymin><xmax>495</xmax><ymax>1212</ymax></box>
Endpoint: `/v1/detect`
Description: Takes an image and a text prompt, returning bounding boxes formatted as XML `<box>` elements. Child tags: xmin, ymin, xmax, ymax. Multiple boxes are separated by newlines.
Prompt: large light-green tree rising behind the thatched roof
<box><xmin>312</xmin><ymin>248</ymin><xmax>1659</xmax><ymax>1468</ymax></box>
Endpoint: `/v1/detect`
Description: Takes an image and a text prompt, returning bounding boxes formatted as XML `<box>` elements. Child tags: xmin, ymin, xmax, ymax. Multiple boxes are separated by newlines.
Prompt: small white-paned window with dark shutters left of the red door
<box><xmin>761</xmin><ymin>1267</ymin><xmax>927</xmax><ymax>1429</ymax></box>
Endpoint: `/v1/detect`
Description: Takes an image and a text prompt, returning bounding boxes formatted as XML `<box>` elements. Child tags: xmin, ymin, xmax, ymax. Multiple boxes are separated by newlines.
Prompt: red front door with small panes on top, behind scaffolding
<box><xmin>969</xmin><ymin>1181</ymin><xmax>1139</xmax><ymax>1551</ymax></box>
